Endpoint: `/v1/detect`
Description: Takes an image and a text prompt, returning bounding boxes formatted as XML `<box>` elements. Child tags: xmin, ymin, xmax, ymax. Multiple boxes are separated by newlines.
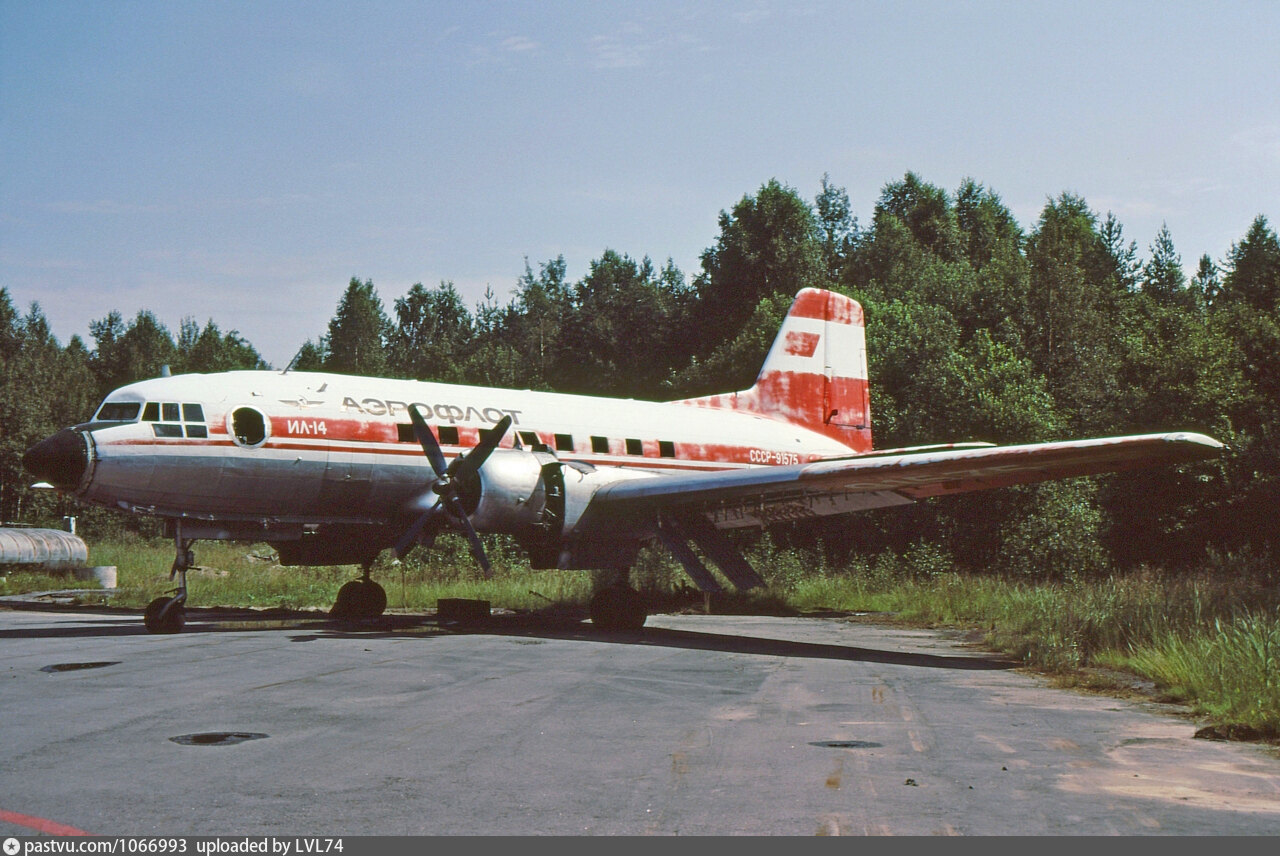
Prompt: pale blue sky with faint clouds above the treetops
<box><xmin>0</xmin><ymin>0</ymin><xmax>1280</xmax><ymax>366</ymax></box>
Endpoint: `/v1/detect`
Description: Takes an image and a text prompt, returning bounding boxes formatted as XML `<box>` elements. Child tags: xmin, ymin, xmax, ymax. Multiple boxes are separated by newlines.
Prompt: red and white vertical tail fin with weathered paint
<box><xmin>682</xmin><ymin>288</ymin><xmax>872</xmax><ymax>452</ymax></box>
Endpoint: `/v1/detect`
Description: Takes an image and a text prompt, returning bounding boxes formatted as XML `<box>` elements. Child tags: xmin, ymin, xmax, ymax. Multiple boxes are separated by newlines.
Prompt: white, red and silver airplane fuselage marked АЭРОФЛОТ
<box><xmin>28</xmin><ymin>371</ymin><xmax>854</xmax><ymax>534</ymax></box>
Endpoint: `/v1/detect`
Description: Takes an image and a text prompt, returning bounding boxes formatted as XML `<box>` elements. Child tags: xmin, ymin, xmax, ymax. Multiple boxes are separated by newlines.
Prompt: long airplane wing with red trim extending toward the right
<box><xmin>575</xmin><ymin>432</ymin><xmax>1222</xmax><ymax>537</ymax></box>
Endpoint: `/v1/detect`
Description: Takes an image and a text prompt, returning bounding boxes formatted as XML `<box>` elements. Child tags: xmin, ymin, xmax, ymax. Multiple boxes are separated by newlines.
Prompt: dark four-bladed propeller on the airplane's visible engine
<box><xmin>396</xmin><ymin>407</ymin><xmax>511</xmax><ymax>576</ymax></box>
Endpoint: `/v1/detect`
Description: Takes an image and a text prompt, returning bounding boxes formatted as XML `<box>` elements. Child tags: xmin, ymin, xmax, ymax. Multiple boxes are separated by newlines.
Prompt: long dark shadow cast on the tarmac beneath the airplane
<box><xmin>0</xmin><ymin>608</ymin><xmax>1018</xmax><ymax>670</ymax></box>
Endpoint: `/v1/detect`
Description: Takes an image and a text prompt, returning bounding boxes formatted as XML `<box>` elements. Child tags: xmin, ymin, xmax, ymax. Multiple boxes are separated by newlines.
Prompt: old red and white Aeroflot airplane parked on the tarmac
<box><xmin>23</xmin><ymin>288</ymin><xmax>1222</xmax><ymax>633</ymax></box>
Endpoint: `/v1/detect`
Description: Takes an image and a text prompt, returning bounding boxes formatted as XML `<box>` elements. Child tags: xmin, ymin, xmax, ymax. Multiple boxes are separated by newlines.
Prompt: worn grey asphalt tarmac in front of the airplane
<box><xmin>0</xmin><ymin>609</ymin><xmax>1280</xmax><ymax>837</ymax></box>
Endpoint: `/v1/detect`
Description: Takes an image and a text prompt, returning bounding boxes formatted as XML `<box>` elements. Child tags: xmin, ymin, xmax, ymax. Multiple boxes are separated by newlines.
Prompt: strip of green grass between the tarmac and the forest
<box><xmin>0</xmin><ymin>537</ymin><xmax>1280</xmax><ymax>738</ymax></box>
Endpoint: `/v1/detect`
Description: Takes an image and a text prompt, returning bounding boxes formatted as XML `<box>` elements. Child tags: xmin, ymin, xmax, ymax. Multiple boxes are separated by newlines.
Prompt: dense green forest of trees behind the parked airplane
<box><xmin>0</xmin><ymin>168</ymin><xmax>1280</xmax><ymax>580</ymax></box>
